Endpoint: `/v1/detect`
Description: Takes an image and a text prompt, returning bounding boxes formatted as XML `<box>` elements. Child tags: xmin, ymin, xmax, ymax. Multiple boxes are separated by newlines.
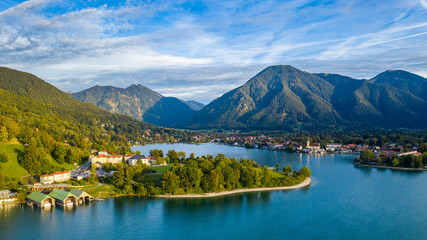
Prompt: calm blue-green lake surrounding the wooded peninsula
<box><xmin>0</xmin><ymin>144</ymin><xmax>427</xmax><ymax>239</ymax></box>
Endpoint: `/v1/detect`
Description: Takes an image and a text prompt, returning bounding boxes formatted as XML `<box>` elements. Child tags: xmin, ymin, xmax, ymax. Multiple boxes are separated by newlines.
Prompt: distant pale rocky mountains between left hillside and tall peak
<box><xmin>70</xmin><ymin>84</ymin><xmax>200</xmax><ymax>127</ymax></box>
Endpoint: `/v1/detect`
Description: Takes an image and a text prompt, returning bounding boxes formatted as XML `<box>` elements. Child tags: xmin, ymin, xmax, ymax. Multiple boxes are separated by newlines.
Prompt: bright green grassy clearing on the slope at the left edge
<box><xmin>0</xmin><ymin>144</ymin><xmax>29</xmax><ymax>178</ymax></box>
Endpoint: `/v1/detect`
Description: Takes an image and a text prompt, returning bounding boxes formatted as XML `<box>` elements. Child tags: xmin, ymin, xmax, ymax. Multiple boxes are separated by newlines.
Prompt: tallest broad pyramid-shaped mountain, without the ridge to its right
<box><xmin>190</xmin><ymin>66</ymin><xmax>341</xmax><ymax>130</ymax></box>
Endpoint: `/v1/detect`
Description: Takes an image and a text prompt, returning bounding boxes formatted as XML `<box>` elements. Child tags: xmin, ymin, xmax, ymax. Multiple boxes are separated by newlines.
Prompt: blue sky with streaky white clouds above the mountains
<box><xmin>0</xmin><ymin>0</ymin><xmax>427</xmax><ymax>103</ymax></box>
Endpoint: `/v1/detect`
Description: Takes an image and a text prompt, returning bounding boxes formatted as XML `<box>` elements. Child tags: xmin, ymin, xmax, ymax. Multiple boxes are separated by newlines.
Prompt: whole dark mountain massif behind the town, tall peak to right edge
<box><xmin>182</xmin><ymin>65</ymin><xmax>427</xmax><ymax>131</ymax></box>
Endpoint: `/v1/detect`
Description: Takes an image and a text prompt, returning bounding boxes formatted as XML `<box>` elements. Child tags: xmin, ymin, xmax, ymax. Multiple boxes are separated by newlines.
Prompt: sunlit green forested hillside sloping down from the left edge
<box><xmin>0</xmin><ymin>68</ymin><xmax>196</xmax><ymax>187</ymax></box>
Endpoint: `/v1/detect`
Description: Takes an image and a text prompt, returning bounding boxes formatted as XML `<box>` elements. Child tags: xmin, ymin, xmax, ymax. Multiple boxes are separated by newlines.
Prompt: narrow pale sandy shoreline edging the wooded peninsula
<box><xmin>153</xmin><ymin>178</ymin><xmax>311</xmax><ymax>198</ymax></box>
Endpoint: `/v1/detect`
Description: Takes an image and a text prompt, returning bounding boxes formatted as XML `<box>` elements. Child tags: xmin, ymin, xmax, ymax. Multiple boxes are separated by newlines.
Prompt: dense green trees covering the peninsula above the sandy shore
<box><xmin>106</xmin><ymin>150</ymin><xmax>311</xmax><ymax>195</ymax></box>
